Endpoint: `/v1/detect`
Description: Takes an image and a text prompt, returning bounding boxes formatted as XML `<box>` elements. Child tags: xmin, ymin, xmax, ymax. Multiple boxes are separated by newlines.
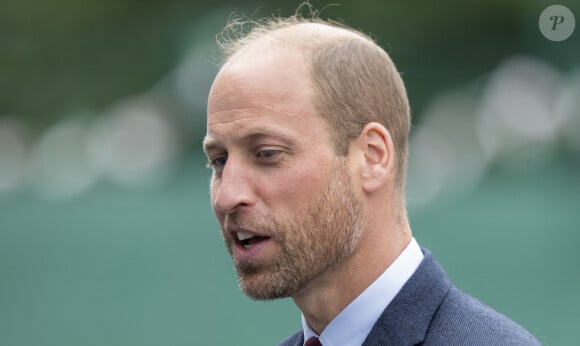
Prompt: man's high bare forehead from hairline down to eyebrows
<box><xmin>206</xmin><ymin>46</ymin><xmax>326</xmax><ymax>147</ymax></box>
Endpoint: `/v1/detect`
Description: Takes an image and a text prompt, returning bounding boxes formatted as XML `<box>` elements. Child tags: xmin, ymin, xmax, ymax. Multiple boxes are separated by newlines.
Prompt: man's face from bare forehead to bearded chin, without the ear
<box><xmin>204</xmin><ymin>49</ymin><xmax>363</xmax><ymax>299</ymax></box>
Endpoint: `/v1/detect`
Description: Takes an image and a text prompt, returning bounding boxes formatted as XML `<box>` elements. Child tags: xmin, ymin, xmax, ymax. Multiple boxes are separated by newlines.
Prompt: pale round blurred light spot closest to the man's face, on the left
<box><xmin>87</xmin><ymin>95</ymin><xmax>182</xmax><ymax>186</ymax></box>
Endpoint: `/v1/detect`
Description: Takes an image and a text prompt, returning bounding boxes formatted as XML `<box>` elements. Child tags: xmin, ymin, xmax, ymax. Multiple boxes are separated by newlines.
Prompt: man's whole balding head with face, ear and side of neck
<box><xmin>204</xmin><ymin>9</ymin><xmax>411</xmax><ymax>310</ymax></box>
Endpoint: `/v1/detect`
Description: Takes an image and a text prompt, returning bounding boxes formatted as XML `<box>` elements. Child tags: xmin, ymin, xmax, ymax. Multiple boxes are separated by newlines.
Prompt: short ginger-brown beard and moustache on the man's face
<box><xmin>222</xmin><ymin>163</ymin><xmax>364</xmax><ymax>300</ymax></box>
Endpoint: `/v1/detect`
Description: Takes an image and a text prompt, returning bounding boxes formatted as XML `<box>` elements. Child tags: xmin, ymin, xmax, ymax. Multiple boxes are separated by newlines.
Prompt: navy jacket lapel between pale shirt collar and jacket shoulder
<box><xmin>363</xmin><ymin>249</ymin><xmax>451</xmax><ymax>346</ymax></box>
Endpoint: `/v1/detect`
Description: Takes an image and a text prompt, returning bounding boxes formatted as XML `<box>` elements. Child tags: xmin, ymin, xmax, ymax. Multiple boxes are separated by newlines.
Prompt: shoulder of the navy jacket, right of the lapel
<box><xmin>425</xmin><ymin>287</ymin><xmax>540</xmax><ymax>345</ymax></box>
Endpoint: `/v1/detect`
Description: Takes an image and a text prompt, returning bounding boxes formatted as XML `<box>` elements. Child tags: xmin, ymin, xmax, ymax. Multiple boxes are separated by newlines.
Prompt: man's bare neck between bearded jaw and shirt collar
<box><xmin>292</xmin><ymin>217</ymin><xmax>411</xmax><ymax>335</ymax></box>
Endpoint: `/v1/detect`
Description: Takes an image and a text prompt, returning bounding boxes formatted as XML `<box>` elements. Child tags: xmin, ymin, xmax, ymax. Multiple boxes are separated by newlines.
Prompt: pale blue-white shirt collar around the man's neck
<box><xmin>302</xmin><ymin>238</ymin><xmax>423</xmax><ymax>346</ymax></box>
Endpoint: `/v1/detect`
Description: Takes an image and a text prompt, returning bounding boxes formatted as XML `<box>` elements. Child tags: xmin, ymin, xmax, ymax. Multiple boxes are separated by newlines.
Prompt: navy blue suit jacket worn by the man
<box><xmin>280</xmin><ymin>249</ymin><xmax>540</xmax><ymax>346</ymax></box>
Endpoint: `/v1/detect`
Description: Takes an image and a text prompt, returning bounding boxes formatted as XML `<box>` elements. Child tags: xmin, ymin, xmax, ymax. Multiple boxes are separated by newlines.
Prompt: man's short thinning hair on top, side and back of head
<box><xmin>217</xmin><ymin>8</ymin><xmax>411</xmax><ymax>192</ymax></box>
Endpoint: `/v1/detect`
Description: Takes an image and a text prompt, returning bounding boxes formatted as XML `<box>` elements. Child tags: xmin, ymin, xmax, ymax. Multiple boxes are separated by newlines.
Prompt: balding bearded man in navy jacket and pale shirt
<box><xmin>204</xmin><ymin>11</ymin><xmax>538</xmax><ymax>346</ymax></box>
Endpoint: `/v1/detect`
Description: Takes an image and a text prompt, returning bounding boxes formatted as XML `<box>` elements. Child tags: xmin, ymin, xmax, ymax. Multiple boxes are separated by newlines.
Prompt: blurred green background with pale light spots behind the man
<box><xmin>0</xmin><ymin>0</ymin><xmax>580</xmax><ymax>346</ymax></box>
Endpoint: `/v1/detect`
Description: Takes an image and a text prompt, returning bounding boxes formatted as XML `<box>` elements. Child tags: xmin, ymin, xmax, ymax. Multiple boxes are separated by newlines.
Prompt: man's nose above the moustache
<box><xmin>211</xmin><ymin>156</ymin><xmax>255</xmax><ymax>214</ymax></box>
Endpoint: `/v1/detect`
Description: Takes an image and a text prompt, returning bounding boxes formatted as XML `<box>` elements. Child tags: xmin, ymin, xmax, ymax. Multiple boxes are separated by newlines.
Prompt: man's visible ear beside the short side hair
<box><xmin>357</xmin><ymin>122</ymin><xmax>395</xmax><ymax>192</ymax></box>
